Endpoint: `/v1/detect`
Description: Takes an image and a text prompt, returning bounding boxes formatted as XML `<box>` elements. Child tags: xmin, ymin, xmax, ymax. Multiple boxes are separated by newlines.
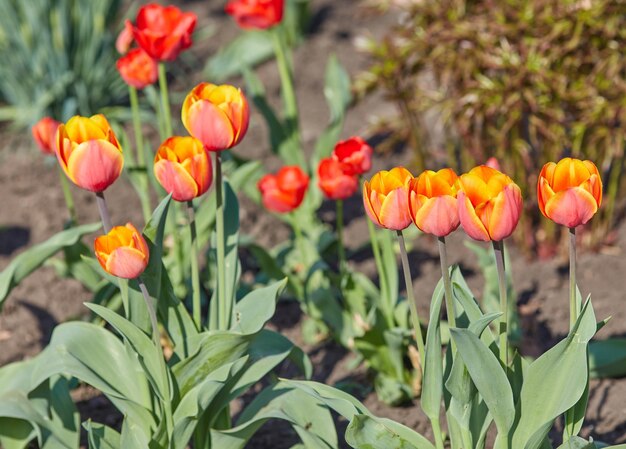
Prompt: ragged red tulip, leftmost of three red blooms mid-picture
<box><xmin>257</xmin><ymin>165</ymin><xmax>309</xmax><ymax>213</ymax></box>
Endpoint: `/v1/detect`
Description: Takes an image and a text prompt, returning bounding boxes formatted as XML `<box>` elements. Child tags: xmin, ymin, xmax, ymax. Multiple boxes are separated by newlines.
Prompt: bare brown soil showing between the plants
<box><xmin>0</xmin><ymin>0</ymin><xmax>626</xmax><ymax>449</ymax></box>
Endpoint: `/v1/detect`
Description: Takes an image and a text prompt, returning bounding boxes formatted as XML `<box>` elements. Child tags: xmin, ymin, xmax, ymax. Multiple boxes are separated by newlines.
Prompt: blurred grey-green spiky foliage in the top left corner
<box><xmin>0</xmin><ymin>0</ymin><xmax>128</xmax><ymax>127</ymax></box>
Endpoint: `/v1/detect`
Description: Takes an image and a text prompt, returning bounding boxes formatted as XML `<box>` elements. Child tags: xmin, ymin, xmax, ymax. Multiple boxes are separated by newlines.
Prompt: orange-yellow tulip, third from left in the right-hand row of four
<box><xmin>457</xmin><ymin>165</ymin><xmax>522</xmax><ymax>242</ymax></box>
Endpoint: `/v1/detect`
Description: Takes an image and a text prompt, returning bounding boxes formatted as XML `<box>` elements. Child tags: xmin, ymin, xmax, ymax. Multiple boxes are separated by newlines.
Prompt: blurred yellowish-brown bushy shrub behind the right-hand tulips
<box><xmin>355</xmin><ymin>0</ymin><xmax>626</xmax><ymax>255</ymax></box>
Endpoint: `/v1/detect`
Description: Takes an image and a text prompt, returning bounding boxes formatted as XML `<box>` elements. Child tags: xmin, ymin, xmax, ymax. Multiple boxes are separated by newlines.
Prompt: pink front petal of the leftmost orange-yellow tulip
<box><xmin>67</xmin><ymin>140</ymin><xmax>124</xmax><ymax>192</ymax></box>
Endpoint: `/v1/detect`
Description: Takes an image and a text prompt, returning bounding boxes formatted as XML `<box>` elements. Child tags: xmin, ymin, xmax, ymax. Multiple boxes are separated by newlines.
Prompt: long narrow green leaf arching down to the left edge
<box><xmin>0</xmin><ymin>223</ymin><xmax>101</xmax><ymax>310</ymax></box>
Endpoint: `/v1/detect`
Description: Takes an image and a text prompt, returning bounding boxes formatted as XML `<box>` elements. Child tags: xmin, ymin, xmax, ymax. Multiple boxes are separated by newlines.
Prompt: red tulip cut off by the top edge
<box><xmin>224</xmin><ymin>0</ymin><xmax>285</xmax><ymax>30</ymax></box>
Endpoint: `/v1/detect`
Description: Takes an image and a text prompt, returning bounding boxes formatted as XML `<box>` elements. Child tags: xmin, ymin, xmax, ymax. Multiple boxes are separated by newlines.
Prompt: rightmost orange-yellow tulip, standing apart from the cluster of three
<box><xmin>537</xmin><ymin>157</ymin><xmax>602</xmax><ymax>228</ymax></box>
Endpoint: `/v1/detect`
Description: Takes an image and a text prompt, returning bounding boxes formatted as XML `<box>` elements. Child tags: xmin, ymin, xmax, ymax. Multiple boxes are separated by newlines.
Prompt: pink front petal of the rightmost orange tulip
<box><xmin>546</xmin><ymin>187</ymin><xmax>598</xmax><ymax>228</ymax></box>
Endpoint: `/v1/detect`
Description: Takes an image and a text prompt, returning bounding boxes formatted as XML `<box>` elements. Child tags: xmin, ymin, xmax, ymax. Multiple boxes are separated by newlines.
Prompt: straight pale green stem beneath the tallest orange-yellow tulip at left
<box><xmin>215</xmin><ymin>152</ymin><xmax>232</xmax><ymax>330</ymax></box>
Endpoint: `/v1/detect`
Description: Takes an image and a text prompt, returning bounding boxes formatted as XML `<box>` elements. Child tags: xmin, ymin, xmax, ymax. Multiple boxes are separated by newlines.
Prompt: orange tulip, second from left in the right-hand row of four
<box><xmin>409</xmin><ymin>168</ymin><xmax>459</xmax><ymax>237</ymax></box>
